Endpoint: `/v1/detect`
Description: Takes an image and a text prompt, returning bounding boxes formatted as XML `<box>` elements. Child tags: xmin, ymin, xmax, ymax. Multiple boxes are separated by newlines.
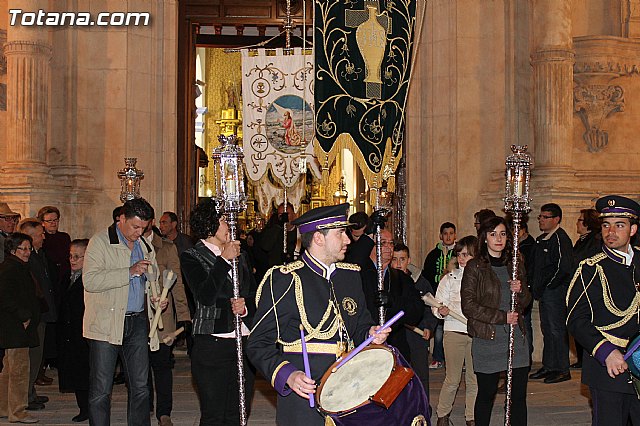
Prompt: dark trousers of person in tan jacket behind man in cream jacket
<box><xmin>148</xmin><ymin>343</ymin><xmax>173</xmax><ymax>420</ymax></box>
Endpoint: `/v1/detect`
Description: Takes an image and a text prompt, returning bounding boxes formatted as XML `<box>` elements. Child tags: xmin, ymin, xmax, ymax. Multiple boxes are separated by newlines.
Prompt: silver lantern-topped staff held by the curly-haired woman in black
<box><xmin>212</xmin><ymin>135</ymin><xmax>247</xmax><ymax>426</ymax></box>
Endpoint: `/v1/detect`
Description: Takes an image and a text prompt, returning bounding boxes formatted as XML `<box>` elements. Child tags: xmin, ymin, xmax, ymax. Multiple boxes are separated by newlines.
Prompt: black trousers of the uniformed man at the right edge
<box><xmin>589</xmin><ymin>387</ymin><xmax>640</xmax><ymax>426</ymax></box>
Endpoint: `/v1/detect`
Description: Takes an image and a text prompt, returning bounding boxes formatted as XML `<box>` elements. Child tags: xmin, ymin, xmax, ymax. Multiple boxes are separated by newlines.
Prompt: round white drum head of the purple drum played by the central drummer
<box><xmin>318</xmin><ymin>348</ymin><xmax>395</xmax><ymax>413</ymax></box>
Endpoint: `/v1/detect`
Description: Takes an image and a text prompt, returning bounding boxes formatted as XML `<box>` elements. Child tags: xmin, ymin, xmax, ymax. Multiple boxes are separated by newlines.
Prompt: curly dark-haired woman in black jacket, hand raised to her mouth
<box><xmin>180</xmin><ymin>198</ymin><xmax>257</xmax><ymax>426</ymax></box>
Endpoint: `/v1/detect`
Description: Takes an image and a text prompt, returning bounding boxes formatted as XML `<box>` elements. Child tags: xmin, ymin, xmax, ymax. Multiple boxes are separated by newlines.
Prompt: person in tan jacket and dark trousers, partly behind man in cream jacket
<box><xmin>144</xmin><ymin>219</ymin><xmax>191</xmax><ymax>426</ymax></box>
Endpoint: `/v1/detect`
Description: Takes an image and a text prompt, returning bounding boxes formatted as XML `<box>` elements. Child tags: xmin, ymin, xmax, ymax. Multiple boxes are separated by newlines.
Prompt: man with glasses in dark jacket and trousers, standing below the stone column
<box><xmin>528</xmin><ymin>203</ymin><xmax>573</xmax><ymax>383</ymax></box>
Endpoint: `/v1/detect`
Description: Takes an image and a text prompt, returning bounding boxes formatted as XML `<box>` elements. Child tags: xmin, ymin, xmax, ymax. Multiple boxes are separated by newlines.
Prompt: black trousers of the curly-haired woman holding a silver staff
<box><xmin>191</xmin><ymin>334</ymin><xmax>255</xmax><ymax>426</ymax></box>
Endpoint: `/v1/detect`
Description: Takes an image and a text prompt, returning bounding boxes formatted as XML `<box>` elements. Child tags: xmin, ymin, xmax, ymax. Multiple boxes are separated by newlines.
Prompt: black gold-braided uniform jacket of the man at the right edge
<box><xmin>567</xmin><ymin>246</ymin><xmax>640</xmax><ymax>393</ymax></box>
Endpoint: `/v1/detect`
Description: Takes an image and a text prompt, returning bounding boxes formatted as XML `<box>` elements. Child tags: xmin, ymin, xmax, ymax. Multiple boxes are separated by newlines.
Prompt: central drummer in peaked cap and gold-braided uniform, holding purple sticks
<box><xmin>247</xmin><ymin>203</ymin><xmax>391</xmax><ymax>426</ymax></box>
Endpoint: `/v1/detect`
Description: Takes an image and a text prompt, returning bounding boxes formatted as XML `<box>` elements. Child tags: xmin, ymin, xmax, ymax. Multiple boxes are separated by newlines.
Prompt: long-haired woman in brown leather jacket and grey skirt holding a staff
<box><xmin>460</xmin><ymin>217</ymin><xmax>531</xmax><ymax>426</ymax></box>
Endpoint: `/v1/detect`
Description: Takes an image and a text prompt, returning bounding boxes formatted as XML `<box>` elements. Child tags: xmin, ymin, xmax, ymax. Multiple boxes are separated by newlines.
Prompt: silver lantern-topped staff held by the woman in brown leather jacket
<box><xmin>504</xmin><ymin>145</ymin><xmax>531</xmax><ymax>426</ymax></box>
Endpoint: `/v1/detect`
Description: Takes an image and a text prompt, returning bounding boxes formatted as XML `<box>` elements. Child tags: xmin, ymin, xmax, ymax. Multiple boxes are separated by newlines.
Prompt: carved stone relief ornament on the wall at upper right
<box><xmin>573</xmin><ymin>84</ymin><xmax>624</xmax><ymax>152</ymax></box>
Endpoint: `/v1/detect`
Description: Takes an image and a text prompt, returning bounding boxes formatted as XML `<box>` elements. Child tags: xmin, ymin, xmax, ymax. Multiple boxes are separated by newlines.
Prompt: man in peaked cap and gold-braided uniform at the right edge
<box><xmin>567</xmin><ymin>195</ymin><xmax>640</xmax><ymax>426</ymax></box>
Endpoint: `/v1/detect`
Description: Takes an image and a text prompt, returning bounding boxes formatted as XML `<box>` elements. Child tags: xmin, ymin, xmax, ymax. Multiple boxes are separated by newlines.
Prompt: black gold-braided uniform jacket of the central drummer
<box><xmin>247</xmin><ymin>252</ymin><xmax>373</xmax><ymax>426</ymax></box>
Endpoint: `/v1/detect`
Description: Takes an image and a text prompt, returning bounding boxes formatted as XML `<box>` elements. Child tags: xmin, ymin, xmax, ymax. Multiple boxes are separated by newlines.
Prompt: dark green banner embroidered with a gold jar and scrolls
<box><xmin>315</xmin><ymin>0</ymin><xmax>416</xmax><ymax>190</ymax></box>
